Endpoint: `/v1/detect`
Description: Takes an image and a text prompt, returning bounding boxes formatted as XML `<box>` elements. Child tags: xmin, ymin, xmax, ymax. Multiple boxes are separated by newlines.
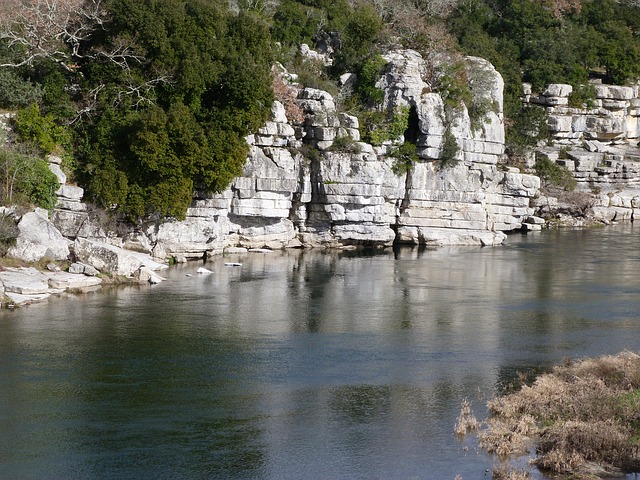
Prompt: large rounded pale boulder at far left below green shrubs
<box><xmin>7</xmin><ymin>211</ymin><xmax>70</xmax><ymax>262</ymax></box>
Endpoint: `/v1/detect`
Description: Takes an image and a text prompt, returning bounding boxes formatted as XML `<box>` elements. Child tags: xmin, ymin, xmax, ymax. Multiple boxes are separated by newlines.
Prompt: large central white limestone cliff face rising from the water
<box><xmin>136</xmin><ymin>50</ymin><xmax>539</xmax><ymax>257</ymax></box>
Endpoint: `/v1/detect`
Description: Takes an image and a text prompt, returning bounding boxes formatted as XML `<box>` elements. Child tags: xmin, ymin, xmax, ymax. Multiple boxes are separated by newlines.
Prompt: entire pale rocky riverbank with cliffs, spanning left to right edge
<box><xmin>6</xmin><ymin>50</ymin><xmax>640</xmax><ymax>303</ymax></box>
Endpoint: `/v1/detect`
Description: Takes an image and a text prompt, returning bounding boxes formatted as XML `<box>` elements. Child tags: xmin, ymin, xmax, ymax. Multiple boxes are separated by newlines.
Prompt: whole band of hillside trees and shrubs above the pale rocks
<box><xmin>0</xmin><ymin>0</ymin><xmax>640</xmax><ymax>222</ymax></box>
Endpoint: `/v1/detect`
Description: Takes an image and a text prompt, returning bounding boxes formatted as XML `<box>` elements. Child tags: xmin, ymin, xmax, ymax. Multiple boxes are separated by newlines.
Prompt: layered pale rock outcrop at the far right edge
<box><xmin>525</xmin><ymin>84</ymin><xmax>640</xmax><ymax>225</ymax></box>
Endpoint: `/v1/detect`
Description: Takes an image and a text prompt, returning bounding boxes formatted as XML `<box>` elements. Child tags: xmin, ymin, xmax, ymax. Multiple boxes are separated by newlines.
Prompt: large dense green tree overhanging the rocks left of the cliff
<box><xmin>75</xmin><ymin>0</ymin><xmax>273</xmax><ymax>219</ymax></box>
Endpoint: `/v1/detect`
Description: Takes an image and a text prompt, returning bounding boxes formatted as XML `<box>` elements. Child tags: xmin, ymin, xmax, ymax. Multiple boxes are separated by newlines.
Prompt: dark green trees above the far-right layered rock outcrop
<box><xmin>448</xmin><ymin>0</ymin><xmax>640</xmax><ymax>152</ymax></box>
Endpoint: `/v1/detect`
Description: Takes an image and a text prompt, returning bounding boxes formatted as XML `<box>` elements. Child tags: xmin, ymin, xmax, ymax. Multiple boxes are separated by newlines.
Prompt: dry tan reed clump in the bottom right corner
<box><xmin>478</xmin><ymin>352</ymin><xmax>640</xmax><ymax>478</ymax></box>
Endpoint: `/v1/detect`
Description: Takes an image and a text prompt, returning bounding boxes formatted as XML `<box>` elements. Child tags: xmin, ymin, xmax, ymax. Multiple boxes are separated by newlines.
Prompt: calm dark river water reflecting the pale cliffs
<box><xmin>0</xmin><ymin>225</ymin><xmax>640</xmax><ymax>480</ymax></box>
